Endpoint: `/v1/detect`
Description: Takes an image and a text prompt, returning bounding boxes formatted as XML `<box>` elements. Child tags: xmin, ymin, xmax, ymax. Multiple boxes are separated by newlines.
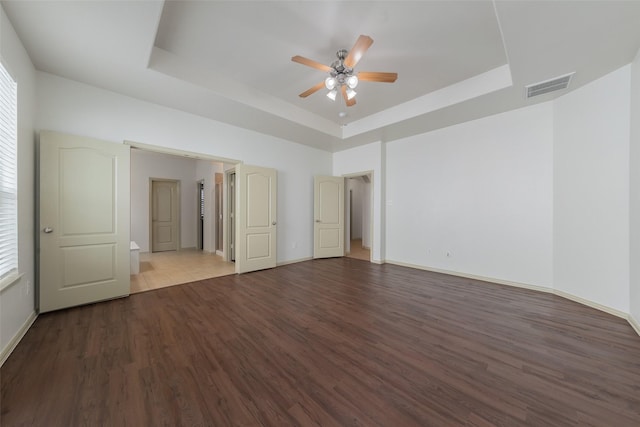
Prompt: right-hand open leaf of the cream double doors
<box><xmin>235</xmin><ymin>164</ymin><xmax>277</xmax><ymax>273</ymax></box>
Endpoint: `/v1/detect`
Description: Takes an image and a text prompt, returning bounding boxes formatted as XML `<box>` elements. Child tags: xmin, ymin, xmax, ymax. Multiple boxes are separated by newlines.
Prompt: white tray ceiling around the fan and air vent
<box><xmin>2</xmin><ymin>0</ymin><xmax>640</xmax><ymax>151</ymax></box>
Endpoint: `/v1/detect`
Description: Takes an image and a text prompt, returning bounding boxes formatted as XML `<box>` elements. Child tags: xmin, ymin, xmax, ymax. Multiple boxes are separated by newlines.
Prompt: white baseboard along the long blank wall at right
<box><xmin>387</xmin><ymin>260</ymin><xmax>640</xmax><ymax>335</ymax></box>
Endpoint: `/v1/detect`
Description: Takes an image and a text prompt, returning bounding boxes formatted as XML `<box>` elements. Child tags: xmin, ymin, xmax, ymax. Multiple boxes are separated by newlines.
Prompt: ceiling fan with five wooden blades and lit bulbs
<box><xmin>291</xmin><ymin>35</ymin><xmax>398</xmax><ymax>107</ymax></box>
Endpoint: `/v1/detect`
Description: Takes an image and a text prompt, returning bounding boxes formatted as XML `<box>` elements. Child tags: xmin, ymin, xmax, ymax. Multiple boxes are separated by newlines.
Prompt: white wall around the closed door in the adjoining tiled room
<box><xmin>131</xmin><ymin>149</ymin><xmax>205</xmax><ymax>252</ymax></box>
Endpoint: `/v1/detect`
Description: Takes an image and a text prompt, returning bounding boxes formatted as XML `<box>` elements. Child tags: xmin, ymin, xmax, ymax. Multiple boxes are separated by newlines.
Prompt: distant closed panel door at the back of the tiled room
<box><xmin>151</xmin><ymin>180</ymin><xmax>179</xmax><ymax>252</ymax></box>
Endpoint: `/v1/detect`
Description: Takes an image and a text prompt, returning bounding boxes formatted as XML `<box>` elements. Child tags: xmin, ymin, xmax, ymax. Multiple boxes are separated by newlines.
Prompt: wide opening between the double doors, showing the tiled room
<box><xmin>127</xmin><ymin>142</ymin><xmax>237</xmax><ymax>293</ymax></box>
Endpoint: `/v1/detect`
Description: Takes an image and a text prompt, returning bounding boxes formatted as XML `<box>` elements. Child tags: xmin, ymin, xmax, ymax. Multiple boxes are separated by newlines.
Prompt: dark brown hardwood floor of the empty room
<box><xmin>0</xmin><ymin>258</ymin><xmax>640</xmax><ymax>427</ymax></box>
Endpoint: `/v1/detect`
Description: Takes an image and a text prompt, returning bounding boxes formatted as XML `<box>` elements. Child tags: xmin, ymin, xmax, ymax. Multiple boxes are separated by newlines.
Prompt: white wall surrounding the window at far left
<box><xmin>0</xmin><ymin>5</ymin><xmax>36</xmax><ymax>359</ymax></box>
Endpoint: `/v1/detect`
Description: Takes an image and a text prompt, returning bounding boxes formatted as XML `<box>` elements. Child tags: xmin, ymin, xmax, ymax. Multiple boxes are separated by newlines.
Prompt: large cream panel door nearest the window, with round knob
<box><xmin>38</xmin><ymin>131</ymin><xmax>130</xmax><ymax>312</ymax></box>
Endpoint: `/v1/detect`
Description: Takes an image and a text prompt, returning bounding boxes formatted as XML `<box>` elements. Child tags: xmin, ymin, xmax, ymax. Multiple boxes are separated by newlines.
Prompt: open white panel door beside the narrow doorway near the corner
<box><xmin>313</xmin><ymin>176</ymin><xmax>344</xmax><ymax>258</ymax></box>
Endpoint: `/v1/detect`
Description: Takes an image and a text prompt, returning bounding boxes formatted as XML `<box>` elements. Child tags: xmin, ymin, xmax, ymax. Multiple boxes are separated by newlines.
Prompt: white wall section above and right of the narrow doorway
<box><xmin>333</xmin><ymin>142</ymin><xmax>385</xmax><ymax>262</ymax></box>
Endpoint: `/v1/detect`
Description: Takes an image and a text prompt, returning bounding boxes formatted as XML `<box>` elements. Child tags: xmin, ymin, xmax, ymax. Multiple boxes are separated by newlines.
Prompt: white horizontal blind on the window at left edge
<box><xmin>0</xmin><ymin>62</ymin><xmax>18</xmax><ymax>279</ymax></box>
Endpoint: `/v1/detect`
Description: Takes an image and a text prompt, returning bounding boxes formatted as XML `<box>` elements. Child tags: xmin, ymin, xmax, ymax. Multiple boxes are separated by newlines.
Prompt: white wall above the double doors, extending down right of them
<box><xmin>36</xmin><ymin>72</ymin><xmax>331</xmax><ymax>262</ymax></box>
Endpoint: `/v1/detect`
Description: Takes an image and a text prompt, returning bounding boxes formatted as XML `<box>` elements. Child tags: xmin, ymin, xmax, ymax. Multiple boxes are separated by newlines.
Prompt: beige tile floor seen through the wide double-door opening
<box><xmin>131</xmin><ymin>249</ymin><xmax>235</xmax><ymax>294</ymax></box>
